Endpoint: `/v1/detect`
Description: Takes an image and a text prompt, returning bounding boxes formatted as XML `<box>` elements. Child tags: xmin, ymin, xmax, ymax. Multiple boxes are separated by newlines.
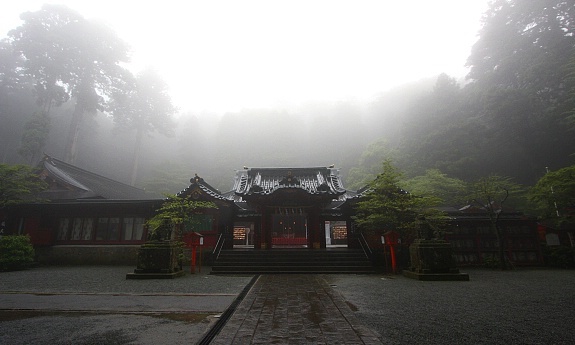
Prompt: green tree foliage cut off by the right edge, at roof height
<box><xmin>529</xmin><ymin>165</ymin><xmax>575</xmax><ymax>226</ymax></box>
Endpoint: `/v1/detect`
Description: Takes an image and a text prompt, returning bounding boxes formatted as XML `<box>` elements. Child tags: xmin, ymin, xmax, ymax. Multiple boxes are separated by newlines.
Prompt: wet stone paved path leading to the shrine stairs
<box><xmin>211</xmin><ymin>274</ymin><xmax>381</xmax><ymax>345</ymax></box>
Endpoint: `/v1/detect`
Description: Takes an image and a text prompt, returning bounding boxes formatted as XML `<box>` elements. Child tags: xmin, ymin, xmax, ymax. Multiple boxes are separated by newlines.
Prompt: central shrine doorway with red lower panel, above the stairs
<box><xmin>271</xmin><ymin>211</ymin><xmax>308</xmax><ymax>248</ymax></box>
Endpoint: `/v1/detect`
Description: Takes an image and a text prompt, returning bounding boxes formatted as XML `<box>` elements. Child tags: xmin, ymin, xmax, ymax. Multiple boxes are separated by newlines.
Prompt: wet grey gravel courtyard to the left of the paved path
<box><xmin>0</xmin><ymin>266</ymin><xmax>251</xmax><ymax>345</ymax></box>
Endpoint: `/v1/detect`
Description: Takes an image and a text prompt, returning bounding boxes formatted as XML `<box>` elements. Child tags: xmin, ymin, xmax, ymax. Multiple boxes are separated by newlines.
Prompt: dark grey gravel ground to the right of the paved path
<box><xmin>325</xmin><ymin>269</ymin><xmax>575</xmax><ymax>344</ymax></box>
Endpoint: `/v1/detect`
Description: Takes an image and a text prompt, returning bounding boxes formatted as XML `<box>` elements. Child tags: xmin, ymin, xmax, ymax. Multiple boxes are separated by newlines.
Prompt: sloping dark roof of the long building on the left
<box><xmin>39</xmin><ymin>156</ymin><xmax>161</xmax><ymax>201</ymax></box>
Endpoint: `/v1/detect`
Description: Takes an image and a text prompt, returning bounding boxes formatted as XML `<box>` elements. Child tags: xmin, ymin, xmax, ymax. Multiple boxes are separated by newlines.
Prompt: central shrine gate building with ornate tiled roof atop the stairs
<box><xmin>179</xmin><ymin>167</ymin><xmax>358</xmax><ymax>249</ymax></box>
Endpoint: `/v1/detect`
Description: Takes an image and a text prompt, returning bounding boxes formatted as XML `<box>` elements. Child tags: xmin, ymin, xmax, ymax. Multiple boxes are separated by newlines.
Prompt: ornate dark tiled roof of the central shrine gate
<box><xmin>233</xmin><ymin>167</ymin><xmax>346</xmax><ymax>198</ymax></box>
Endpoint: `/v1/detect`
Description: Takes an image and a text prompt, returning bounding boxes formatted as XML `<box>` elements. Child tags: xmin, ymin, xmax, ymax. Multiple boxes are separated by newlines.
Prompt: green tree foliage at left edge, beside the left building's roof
<box><xmin>0</xmin><ymin>164</ymin><xmax>47</xmax><ymax>209</ymax></box>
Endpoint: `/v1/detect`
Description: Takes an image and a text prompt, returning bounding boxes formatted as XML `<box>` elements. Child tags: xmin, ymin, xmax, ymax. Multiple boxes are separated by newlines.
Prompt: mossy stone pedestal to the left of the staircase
<box><xmin>126</xmin><ymin>241</ymin><xmax>184</xmax><ymax>279</ymax></box>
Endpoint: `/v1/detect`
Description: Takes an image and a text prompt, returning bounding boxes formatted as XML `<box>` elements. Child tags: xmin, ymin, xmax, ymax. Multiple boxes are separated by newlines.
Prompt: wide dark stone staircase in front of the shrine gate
<box><xmin>211</xmin><ymin>248</ymin><xmax>375</xmax><ymax>274</ymax></box>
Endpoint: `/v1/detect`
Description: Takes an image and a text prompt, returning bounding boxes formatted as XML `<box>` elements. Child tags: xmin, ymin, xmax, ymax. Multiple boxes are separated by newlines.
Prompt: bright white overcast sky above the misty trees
<box><xmin>0</xmin><ymin>0</ymin><xmax>488</xmax><ymax>112</ymax></box>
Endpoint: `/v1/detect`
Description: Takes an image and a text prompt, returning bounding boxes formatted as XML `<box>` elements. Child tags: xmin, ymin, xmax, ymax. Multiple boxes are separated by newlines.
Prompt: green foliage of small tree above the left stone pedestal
<box><xmin>147</xmin><ymin>194</ymin><xmax>218</xmax><ymax>239</ymax></box>
